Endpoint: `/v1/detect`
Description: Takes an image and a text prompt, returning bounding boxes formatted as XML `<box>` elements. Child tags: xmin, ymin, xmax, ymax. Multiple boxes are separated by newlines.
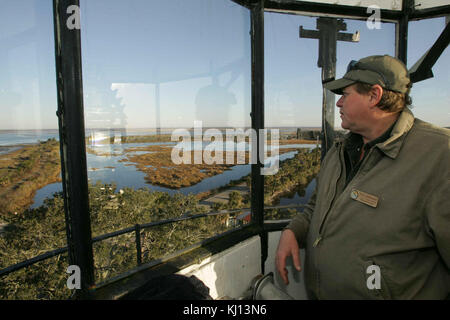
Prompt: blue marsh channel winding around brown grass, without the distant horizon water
<box><xmin>31</xmin><ymin>142</ymin><xmax>315</xmax><ymax>208</ymax></box>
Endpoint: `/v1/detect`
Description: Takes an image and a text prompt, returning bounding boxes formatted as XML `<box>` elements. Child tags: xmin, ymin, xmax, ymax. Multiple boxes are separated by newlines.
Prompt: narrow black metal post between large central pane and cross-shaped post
<box><xmin>251</xmin><ymin>0</ymin><xmax>267</xmax><ymax>273</ymax></box>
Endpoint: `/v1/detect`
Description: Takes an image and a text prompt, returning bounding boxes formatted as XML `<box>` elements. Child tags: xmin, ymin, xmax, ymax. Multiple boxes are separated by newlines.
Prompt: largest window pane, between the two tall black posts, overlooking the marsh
<box><xmin>80</xmin><ymin>0</ymin><xmax>251</xmax><ymax>281</ymax></box>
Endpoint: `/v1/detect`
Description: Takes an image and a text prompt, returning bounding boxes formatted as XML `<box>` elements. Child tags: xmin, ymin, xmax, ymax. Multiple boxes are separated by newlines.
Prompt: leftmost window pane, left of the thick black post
<box><xmin>0</xmin><ymin>0</ymin><xmax>70</xmax><ymax>299</ymax></box>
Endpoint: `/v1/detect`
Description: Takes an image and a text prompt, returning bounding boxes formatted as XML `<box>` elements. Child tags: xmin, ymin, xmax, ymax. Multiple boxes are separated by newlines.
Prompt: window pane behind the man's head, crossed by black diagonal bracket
<box><xmin>408</xmin><ymin>18</ymin><xmax>450</xmax><ymax>127</ymax></box>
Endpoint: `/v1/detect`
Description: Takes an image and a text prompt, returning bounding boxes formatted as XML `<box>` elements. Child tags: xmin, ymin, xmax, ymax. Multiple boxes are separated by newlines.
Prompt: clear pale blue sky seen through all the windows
<box><xmin>0</xmin><ymin>0</ymin><xmax>450</xmax><ymax>129</ymax></box>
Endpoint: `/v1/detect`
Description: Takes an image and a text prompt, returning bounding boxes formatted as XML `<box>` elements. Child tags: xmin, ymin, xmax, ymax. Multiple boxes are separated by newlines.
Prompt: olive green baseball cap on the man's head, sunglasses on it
<box><xmin>324</xmin><ymin>55</ymin><xmax>411</xmax><ymax>94</ymax></box>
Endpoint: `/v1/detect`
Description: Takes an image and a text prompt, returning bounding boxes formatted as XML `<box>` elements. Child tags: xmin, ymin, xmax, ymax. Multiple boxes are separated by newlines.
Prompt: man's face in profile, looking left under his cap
<box><xmin>336</xmin><ymin>84</ymin><xmax>371</xmax><ymax>133</ymax></box>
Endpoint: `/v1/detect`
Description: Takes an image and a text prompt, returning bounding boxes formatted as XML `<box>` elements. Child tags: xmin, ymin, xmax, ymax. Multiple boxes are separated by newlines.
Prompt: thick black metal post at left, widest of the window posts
<box><xmin>53</xmin><ymin>0</ymin><xmax>94</xmax><ymax>299</ymax></box>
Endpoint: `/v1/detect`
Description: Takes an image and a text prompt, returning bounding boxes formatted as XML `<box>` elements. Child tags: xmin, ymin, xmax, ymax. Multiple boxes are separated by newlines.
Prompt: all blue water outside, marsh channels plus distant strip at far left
<box><xmin>0</xmin><ymin>130</ymin><xmax>315</xmax><ymax>208</ymax></box>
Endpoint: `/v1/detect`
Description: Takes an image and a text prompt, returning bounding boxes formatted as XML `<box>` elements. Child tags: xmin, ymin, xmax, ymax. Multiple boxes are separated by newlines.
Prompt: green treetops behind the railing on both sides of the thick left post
<box><xmin>0</xmin><ymin>183</ymin><xmax>227</xmax><ymax>299</ymax></box>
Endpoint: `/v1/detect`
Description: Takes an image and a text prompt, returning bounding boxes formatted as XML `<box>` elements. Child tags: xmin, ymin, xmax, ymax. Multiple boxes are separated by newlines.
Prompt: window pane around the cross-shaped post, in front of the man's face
<box><xmin>264</xmin><ymin>13</ymin><xmax>395</xmax><ymax>219</ymax></box>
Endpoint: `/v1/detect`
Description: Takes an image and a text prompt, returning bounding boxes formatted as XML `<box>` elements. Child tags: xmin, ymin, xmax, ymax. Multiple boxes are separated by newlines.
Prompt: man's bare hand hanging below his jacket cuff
<box><xmin>275</xmin><ymin>229</ymin><xmax>301</xmax><ymax>284</ymax></box>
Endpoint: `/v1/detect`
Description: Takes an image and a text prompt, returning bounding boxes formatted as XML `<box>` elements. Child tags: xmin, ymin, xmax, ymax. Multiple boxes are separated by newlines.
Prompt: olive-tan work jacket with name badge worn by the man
<box><xmin>287</xmin><ymin>109</ymin><xmax>450</xmax><ymax>299</ymax></box>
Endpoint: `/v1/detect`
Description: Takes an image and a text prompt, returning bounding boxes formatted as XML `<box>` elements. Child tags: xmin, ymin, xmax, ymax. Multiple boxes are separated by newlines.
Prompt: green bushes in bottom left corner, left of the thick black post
<box><xmin>0</xmin><ymin>194</ymin><xmax>71</xmax><ymax>299</ymax></box>
